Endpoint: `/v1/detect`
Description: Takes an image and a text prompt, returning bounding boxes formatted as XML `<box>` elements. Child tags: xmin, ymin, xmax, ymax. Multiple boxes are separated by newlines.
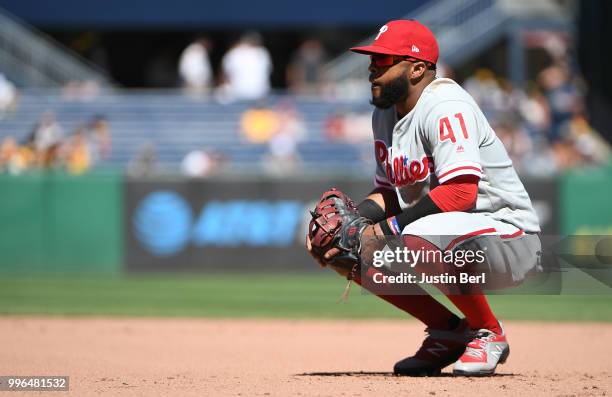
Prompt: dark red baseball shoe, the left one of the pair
<box><xmin>393</xmin><ymin>319</ymin><xmax>470</xmax><ymax>376</ymax></box>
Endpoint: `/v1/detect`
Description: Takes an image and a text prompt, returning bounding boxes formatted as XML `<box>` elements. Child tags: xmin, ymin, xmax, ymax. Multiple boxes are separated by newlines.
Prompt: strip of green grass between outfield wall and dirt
<box><xmin>0</xmin><ymin>274</ymin><xmax>612</xmax><ymax>321</ymax></box>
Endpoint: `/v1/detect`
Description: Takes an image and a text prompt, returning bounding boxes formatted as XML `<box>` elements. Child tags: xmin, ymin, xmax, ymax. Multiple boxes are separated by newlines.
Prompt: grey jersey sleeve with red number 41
<box><xmin>424</xmin><ymin>101</ymin><xmax>483</xmax><ymax>184</ymax></box>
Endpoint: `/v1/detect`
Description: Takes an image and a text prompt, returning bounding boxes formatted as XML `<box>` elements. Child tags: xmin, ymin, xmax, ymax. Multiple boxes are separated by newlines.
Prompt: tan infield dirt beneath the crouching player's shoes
<box><xmin>0</xmin><ymin>317</ymin><xmax>612</xmax><ymax>396</ymax></box>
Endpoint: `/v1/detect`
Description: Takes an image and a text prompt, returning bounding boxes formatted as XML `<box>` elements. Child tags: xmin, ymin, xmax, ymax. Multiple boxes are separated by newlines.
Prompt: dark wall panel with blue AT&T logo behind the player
<box><xmin>124</xmin><ymin>178</ymin><xmax>558</xmax><ymax>272</ymax></box>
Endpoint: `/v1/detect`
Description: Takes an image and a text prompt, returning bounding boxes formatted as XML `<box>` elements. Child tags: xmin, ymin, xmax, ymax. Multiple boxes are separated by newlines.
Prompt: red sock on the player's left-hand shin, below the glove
<box><xmin>354</xmin><ymin>268</ymin><xmax>459</xmax><ymax>330</ymax></box>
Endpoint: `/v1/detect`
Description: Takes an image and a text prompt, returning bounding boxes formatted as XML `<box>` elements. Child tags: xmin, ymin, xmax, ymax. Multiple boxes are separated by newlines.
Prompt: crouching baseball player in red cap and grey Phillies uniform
<box><xmin>307</xmin><ymin>20</ymin><xmax>541</xmax><ymax>375</ymax></box>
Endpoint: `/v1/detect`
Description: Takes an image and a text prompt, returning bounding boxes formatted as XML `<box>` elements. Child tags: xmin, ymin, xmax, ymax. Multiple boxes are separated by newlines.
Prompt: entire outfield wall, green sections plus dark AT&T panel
<box><xmin>0</xmin><ymin>168</ymin><xmax>612</xmax><ymax>273</ymax></box>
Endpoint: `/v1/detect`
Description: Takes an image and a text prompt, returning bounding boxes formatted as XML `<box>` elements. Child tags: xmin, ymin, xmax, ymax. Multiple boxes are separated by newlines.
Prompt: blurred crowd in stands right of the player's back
<box><xmin>463</xmin><ymin>61</ymin><xmax>610</xmax><ymax>176</ymax></box>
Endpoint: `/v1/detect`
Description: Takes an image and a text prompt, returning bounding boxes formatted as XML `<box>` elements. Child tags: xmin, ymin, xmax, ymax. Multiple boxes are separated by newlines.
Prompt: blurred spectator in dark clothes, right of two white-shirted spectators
<box><xmin>286</xmin><ymin>38</ymin><xmax>327</xmax><ymax>95</ymax></box>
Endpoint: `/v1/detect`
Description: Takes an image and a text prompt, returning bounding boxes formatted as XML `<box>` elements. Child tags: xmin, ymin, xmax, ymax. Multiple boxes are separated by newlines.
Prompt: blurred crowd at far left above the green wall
<box><xmin>0</xmin><ymin>111</ymin><xmax>111</xmax><ymax>174</ymax></box>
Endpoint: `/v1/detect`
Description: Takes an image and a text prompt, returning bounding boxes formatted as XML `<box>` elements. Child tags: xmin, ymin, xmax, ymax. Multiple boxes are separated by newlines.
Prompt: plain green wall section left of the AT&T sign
<box><xmin>0</xmin><ymin>173</ymin><xmax>123</xmax><ymax>273</ymax></box>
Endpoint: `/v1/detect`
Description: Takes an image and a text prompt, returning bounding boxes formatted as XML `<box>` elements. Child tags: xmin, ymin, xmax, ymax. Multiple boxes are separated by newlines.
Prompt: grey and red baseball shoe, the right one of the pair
<box><xmin>453</xmin><ymin>323</ymin><xmax>510</xmax><ymax>376</ymax></box>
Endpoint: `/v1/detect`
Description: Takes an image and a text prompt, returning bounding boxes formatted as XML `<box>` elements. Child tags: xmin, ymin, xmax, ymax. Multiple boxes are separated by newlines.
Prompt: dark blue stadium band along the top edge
<box><xmin>0</xmin><ymin>0</ymin><xmax>428</xmax><ymax>30</ymax></box>
